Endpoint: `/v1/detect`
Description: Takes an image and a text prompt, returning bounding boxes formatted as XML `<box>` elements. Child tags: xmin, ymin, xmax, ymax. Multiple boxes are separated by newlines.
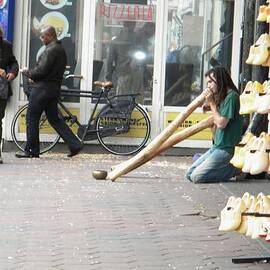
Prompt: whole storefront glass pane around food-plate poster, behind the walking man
<box><xmin>29</xmin><ymin>0</ymin><xmax>84</xmax><ymax>102</ymax></box>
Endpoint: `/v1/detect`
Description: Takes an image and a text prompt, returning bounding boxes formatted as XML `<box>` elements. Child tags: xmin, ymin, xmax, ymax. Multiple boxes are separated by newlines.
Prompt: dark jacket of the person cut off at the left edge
<box><xmin>0</xmin><ymin>38</ymin><xmax>19</xmax><ymax>96</ymax></box>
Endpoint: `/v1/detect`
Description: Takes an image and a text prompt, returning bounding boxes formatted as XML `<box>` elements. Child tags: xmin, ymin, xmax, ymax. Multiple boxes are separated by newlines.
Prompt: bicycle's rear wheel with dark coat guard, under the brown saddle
<box><xmin>96</xmin><ymin>104</ymin><xmax>151</xmax><ymax>156</ymax></box>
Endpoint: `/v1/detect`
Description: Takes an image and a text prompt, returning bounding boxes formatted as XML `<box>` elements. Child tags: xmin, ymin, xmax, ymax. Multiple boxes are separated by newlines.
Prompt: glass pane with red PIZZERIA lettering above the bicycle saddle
<box><xmin>93</xmin><ymin>0</ymin><xmax>155</xmax><ymax>105</ymax></box>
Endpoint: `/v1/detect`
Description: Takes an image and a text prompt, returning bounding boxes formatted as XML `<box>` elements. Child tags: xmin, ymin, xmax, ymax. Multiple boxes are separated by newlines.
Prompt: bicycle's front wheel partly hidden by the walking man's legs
<box><xmin>11</xmin><ymin>104</ymin><xmax>60</xmax><ymax>154</ymax></box>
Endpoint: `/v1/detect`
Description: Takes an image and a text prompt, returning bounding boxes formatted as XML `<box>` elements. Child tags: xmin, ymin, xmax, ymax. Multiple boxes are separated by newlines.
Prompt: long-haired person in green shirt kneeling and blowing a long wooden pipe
<box><xmin>186</xmin><ymin>66</ymin><xmax>243</xmax><ymax>183</ymax></box>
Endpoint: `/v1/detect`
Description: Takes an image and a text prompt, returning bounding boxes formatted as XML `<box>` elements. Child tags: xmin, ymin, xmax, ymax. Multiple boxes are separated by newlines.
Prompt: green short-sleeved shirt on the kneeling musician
<box><xmin>214</xmin><ymin>90</ymin><xmax>243</xmax><ymax>154</ymax></box>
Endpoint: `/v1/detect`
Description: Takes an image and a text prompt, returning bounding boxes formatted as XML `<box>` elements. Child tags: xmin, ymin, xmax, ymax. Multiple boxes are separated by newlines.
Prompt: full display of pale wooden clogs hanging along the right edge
<box><xmin>219</xmin><ymin>0</ymin><xmax>270</xmax><ymax>263</ymax></box>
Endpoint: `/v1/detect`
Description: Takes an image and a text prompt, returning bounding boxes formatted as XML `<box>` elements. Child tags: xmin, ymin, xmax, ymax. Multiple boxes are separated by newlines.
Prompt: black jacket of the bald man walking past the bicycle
<box><xmin>25</xmin><ymin>41</ymin><xmax>67</xmax><ymax>96</ymax></box>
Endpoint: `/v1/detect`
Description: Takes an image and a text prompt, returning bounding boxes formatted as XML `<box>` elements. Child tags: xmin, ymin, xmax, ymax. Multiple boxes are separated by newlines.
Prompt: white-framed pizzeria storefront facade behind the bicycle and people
<box><xmin>3</xmin><ymin>0</ymin><xmax>244</xmax><ymax>148</ymax></box>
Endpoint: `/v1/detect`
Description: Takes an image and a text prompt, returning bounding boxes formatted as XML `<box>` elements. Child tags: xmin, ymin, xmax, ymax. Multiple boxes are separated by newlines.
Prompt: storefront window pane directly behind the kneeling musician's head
<box><xmin>164</xmin><ymin>0</ymin><xmax>234</xmax><ymax>106</ymax></box>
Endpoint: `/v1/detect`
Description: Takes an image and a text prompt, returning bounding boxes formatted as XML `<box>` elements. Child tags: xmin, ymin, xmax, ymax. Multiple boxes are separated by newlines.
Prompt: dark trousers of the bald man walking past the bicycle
<box><xmin>25</xmin><ymin>88</ymin><xmax>81</xmax><ymax>155</ymax></box>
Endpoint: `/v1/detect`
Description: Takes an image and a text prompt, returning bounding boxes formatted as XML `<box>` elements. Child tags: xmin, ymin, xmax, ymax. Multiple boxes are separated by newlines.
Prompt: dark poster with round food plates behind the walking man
<box><xmin>29</xmin><ymin>0</ymin><xmax>77</xmax><ymax>73</ymax></box>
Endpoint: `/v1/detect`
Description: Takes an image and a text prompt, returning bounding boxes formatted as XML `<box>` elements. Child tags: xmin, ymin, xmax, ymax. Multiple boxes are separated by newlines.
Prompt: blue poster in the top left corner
<box><xmin>0</xmin><ymin>0</ymin><xmax>15</xmax><ymax>42</ymax></box>
